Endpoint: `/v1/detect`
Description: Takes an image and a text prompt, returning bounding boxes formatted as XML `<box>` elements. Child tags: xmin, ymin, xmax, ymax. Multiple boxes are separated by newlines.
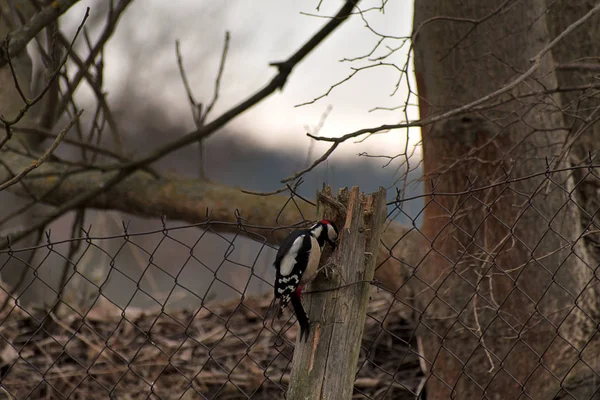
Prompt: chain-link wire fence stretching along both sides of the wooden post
<box><xmin>0</xmin><ymin>165</ymin><xmax>598</xmax><ymax>399</ymax></box>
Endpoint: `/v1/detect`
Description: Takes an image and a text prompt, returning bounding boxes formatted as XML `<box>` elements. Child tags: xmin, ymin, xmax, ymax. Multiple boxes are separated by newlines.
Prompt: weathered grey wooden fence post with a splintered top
<box><xmin>286</xmin><ymin>186</ymin><xmax>386</xmax><ymax>400</ymax></box>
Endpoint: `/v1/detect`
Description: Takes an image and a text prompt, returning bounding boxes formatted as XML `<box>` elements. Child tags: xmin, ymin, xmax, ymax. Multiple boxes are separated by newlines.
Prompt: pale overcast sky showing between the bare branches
<box><xmin>63</xmin><ymin>0</ymin><xmax>419</xmax><ymax>166</ymax></box>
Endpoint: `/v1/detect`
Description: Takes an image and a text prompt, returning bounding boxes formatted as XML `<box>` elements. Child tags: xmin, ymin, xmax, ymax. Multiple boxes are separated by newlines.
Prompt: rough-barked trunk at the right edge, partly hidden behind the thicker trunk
<box><xmin>546</xmin><ymin>0</ymin><xmax>600</xmax><ymax>399</ymax></box>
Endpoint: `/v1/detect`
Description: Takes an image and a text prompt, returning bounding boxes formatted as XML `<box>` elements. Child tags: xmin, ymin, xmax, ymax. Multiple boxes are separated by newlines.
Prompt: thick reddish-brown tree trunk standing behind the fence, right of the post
<box><xmin>413</xmin><ymin>0</ymin><xmax>597</xmax><ymax>399</ymax></box>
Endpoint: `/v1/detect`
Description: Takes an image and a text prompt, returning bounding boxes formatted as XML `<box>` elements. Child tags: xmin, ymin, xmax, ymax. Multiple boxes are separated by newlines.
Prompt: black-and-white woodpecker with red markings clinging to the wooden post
<box><xmin>273</xmin><ymin>219</ymin><xmax>338</xmax><ymax>341</ymax></box>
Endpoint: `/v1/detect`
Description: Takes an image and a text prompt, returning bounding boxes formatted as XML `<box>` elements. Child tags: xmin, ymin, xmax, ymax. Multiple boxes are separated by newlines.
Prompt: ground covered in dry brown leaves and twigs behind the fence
<box><xmin>0</xmin><ymin>292</ymin><xmax>422</xmax><ymax>400</ymax></box>
